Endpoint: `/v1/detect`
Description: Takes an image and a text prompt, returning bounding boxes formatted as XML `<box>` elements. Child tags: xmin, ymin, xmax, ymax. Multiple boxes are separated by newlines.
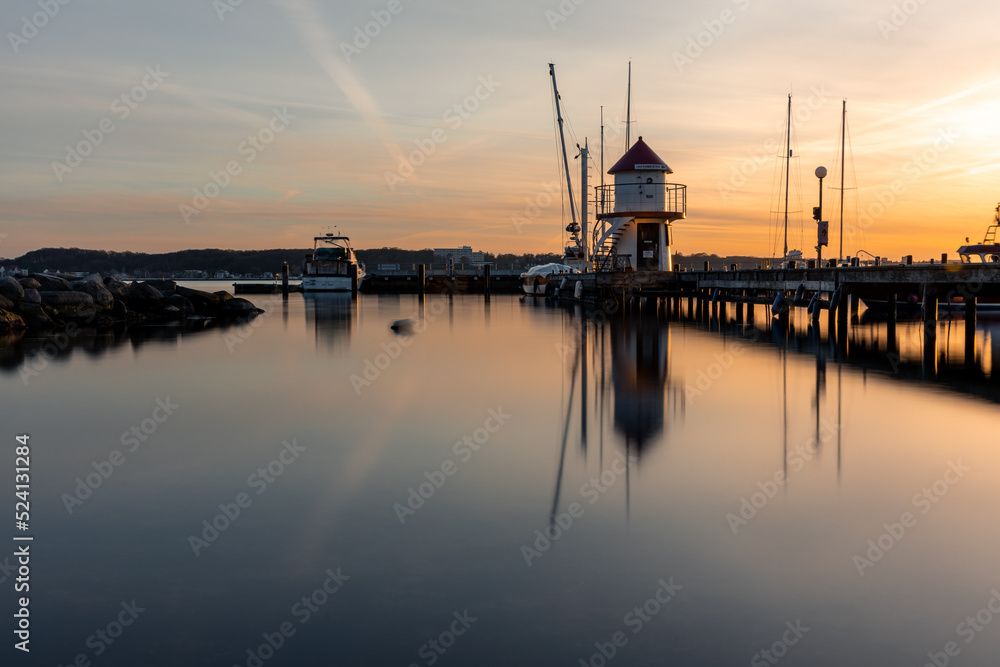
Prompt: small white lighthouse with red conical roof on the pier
<box><xmin>594</xmin><ymin>137</ymin><xmax>687</xmax><ymax>271</ymax></box>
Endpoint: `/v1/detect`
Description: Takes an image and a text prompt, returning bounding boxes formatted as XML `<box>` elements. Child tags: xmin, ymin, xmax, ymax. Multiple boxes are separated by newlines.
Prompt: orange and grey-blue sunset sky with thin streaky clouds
<box><xmin>0</xmin><ymin>0</ymin><xmax>1000</xmax><ymax>259</ymax></box>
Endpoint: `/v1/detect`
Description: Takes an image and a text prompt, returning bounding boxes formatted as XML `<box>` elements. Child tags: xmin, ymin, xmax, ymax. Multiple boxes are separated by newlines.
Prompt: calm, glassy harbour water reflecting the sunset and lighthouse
<box><xmin>0</xmin><ymin>284</ymin><xmax>1000</xmax><ymax>667</ymax></box>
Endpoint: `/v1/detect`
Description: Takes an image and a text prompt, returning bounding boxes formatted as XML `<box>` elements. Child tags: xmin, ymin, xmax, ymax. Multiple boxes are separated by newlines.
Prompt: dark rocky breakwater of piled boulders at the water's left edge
<box><xmin>0</xmin><ymin>273</ymin><xmax>264</xmax><ymax>332</ymax></box>
